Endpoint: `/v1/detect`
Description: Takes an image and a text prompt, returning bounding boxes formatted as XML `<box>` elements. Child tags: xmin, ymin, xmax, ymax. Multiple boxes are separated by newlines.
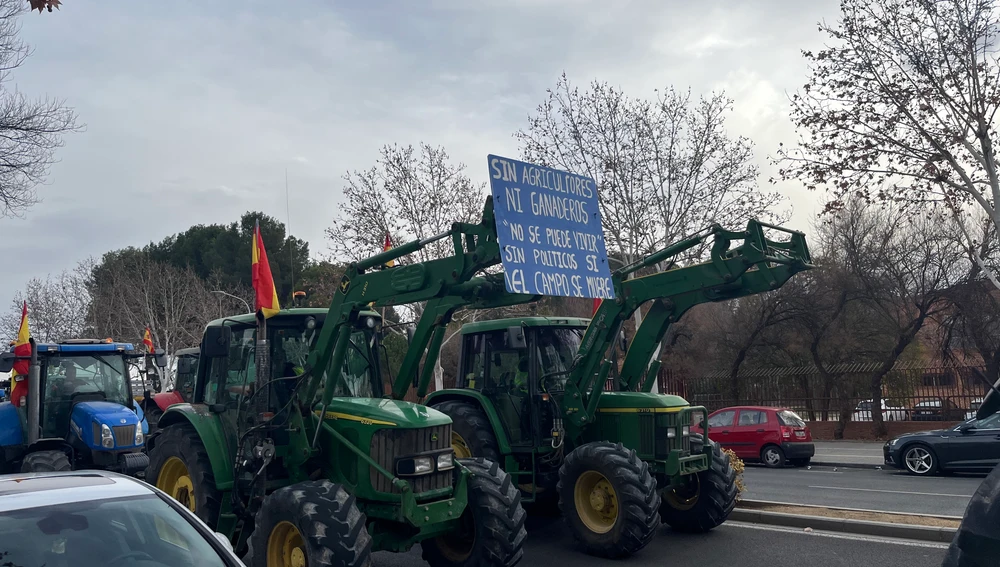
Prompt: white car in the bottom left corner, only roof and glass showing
<box><xmin>0</xmin><ymin>471</ymin><xmax>243</xmax><ymax>567</ymax></box>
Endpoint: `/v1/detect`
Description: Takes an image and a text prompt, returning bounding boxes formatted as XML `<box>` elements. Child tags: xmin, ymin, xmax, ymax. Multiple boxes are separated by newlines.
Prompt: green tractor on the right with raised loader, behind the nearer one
<box><xmin>397</xmin><ymin>221</ymin><xmax>811</xmax><ymax>557</ymax></box>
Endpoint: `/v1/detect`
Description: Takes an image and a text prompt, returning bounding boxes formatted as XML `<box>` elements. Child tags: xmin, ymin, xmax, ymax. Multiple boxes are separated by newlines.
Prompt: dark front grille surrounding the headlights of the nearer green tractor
<box><xmin>369</xmin><ymin>424</ymin><xmax>454</xmax><ymax>494</ymax></box>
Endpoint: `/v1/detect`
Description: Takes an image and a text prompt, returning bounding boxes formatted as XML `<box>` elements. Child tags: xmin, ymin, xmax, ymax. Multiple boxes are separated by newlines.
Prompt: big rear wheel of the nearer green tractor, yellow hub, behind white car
<box><xmin>145</xmin><ymin>423</ymin><xmax>222</xmax><ymax>530</ymax></box>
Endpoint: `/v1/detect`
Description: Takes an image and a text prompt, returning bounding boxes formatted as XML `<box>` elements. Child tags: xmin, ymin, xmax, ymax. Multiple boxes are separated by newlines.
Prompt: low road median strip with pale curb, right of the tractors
<box><xmin>729</xmin><ymin>508</ymin><xmax>958</xmax><ymax>543</ymax></box>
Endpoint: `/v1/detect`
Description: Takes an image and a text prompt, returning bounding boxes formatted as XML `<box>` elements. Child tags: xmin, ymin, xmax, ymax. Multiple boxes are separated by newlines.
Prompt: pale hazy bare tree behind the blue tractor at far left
<box><xmin>3</xmin><ymin>259</ymin><xmax>94</xmax><ymax>342</ymax></box>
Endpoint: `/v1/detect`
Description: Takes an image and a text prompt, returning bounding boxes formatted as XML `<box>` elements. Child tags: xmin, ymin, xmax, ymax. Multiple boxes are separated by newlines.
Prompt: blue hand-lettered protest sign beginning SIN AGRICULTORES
<box><xmin>487</xmin><ymin>155</ymin><xmax>615</xmax><ymax>299</ymax></box>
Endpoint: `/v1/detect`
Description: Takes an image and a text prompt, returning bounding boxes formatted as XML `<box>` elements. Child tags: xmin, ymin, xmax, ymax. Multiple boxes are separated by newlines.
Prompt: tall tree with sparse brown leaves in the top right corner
<box><xmin>777</xmin><ymin>0</ymin><xmax>1000</xmax><ymax>288</ymax></box>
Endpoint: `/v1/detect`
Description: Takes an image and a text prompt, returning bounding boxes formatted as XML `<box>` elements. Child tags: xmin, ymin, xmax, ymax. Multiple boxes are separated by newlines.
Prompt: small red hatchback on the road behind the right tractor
<box><xmin>708</xmin><ymin>406</ymin><xmax>816</xmax><ymax>468</ymax></box>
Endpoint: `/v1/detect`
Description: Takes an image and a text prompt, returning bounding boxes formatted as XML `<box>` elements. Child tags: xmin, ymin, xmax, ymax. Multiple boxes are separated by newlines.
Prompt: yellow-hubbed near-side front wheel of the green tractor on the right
<box><xmin>558</xmin><ymin>441</ymin><xmax>660</xmax><ymax>558</ymax></box>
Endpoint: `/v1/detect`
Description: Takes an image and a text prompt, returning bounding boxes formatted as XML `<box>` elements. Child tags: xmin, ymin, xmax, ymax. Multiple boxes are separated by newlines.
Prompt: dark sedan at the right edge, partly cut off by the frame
<box><xmin>882</xmin><ymin>413</ymin><xmax>1000</xmax><ymax>476</ymax></box>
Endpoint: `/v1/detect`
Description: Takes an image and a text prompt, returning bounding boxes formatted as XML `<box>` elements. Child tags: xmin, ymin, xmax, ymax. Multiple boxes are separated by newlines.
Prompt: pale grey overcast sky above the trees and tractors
<box><xmin>0</xmin><ymin>0</ymin><xmax>838</xmax><ymax>307</ymax></box>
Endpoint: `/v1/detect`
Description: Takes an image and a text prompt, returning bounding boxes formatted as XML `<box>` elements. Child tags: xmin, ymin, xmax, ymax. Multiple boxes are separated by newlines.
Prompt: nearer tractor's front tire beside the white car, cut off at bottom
<box><xmin>244</xmin><ymin>480</ymin><xmax>372</xmax><ymax>567</ymax></box>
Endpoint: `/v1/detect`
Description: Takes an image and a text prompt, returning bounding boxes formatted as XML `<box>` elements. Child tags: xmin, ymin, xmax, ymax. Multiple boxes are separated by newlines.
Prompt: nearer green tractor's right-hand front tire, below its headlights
<box><xmin>424</xmin><ymin>457</ymin><xmax>528</xmax><ymax>567</ymax></box>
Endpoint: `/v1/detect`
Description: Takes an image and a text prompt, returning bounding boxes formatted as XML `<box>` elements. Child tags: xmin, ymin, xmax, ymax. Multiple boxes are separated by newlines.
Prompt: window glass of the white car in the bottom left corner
<box><xmin>0</xmin><ymin>495</ymin><xmax>228</xmax><ymax>567</ymax></box>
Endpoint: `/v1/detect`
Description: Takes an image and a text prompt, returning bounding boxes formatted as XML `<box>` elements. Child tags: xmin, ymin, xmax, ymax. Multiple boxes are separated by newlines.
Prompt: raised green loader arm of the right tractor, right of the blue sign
<box><xmin>563</xmin><ymin>220</ymin><xmax>813</xmax><ymax>427</ymax></box>
